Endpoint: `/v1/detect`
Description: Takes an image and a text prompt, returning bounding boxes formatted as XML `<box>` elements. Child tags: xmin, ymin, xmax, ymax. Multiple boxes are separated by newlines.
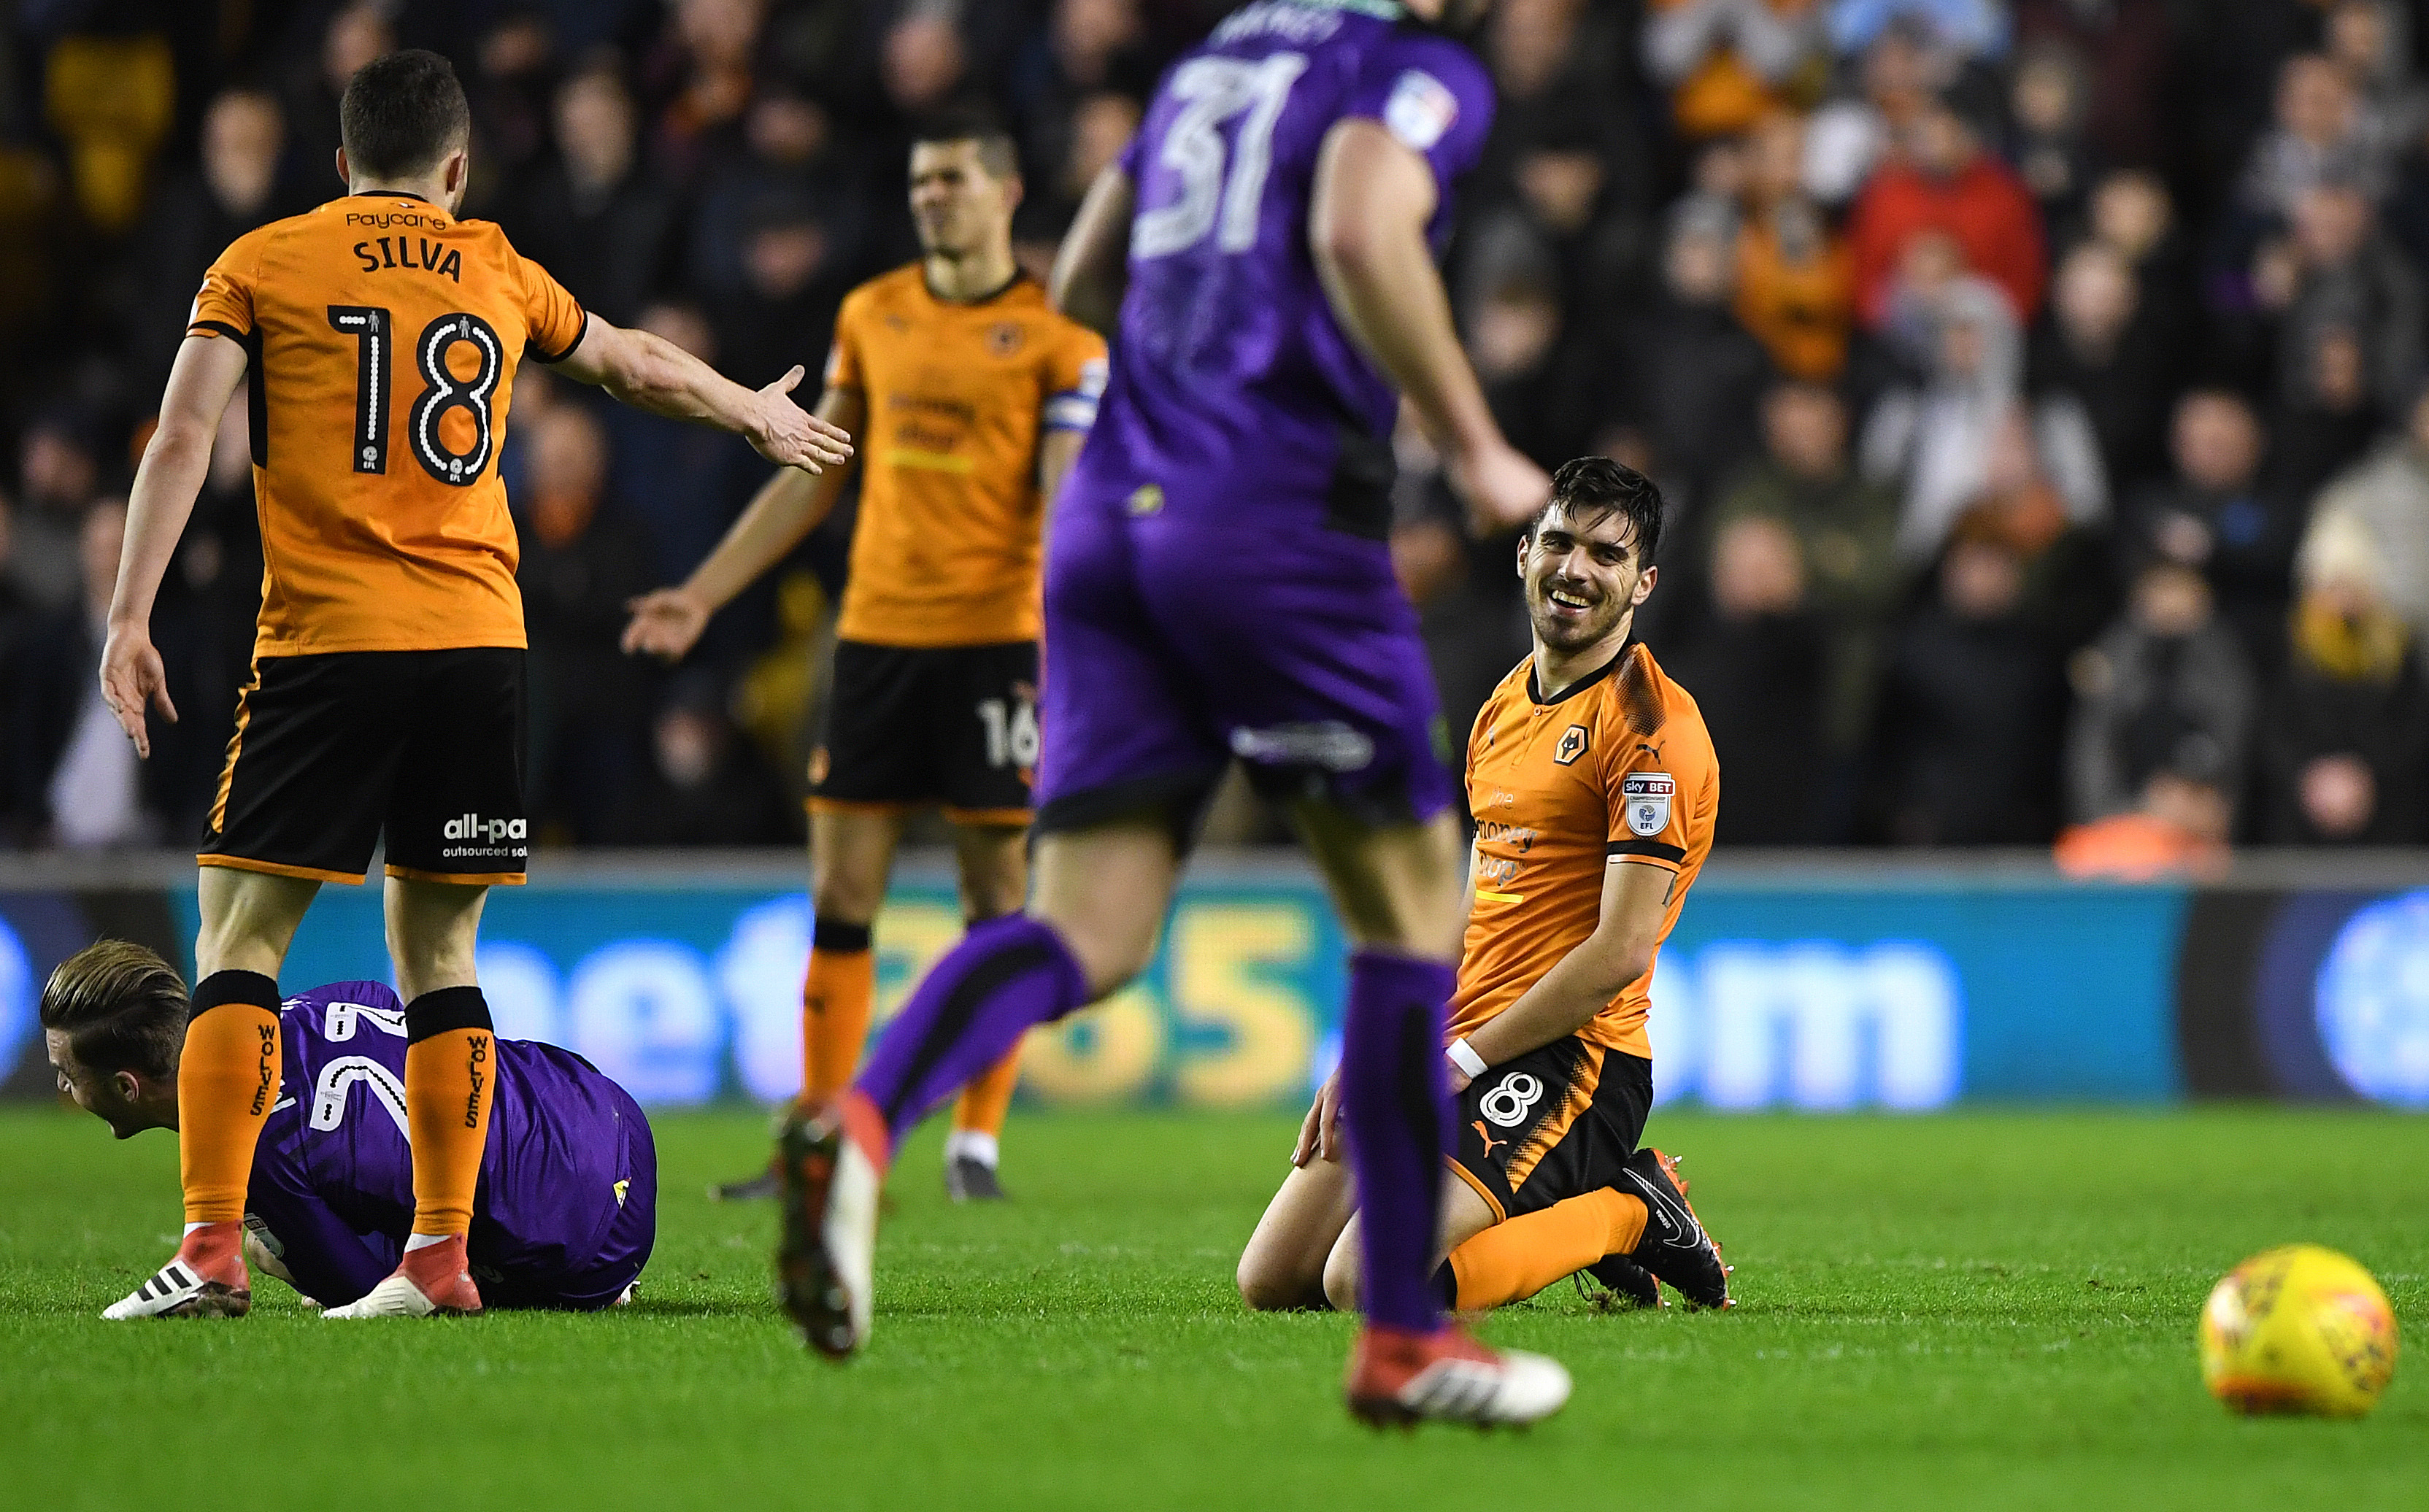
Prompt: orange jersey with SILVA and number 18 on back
<box><xmin>187</xmin><ymin>192</ymin><xmax>585</xmax><ymax>655</ymax></box>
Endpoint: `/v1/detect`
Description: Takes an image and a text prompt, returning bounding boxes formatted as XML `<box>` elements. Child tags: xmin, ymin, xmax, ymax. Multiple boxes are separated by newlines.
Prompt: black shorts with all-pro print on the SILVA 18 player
<box><xmin>197</xmin><ymin>646</ymin><xmax>530</xmax><ymax>881</ymax></box>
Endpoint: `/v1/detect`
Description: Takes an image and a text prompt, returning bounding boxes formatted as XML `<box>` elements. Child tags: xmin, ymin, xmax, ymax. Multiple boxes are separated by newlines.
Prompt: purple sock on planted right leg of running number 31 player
<box><xmin>1341</xmin><ymin>952</ymin><xmax>1458</xmax><ymax>1332</ymax></box>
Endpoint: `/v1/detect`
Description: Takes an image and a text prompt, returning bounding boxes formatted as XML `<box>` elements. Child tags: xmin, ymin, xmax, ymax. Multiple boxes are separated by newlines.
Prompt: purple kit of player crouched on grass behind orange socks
<box><xmin>245</xmin><ymin>983</ymin><xmax>658</xmax><ymax>1311</ymax></box>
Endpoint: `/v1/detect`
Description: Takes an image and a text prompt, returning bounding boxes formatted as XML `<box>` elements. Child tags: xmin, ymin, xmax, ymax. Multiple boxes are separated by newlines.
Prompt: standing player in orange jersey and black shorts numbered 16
<box><xmin>624</xmin><ymin>121</ymin><xmax>1105</xmax><ymax>1201</ymax></box>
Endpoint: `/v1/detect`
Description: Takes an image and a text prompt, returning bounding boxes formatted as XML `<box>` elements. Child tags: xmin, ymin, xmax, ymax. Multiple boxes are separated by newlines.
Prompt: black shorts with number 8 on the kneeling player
<box><xmin>1452</xmin><ymin>1034</ymin><xmax>1654</xmax><ymax>1221</ymax></box>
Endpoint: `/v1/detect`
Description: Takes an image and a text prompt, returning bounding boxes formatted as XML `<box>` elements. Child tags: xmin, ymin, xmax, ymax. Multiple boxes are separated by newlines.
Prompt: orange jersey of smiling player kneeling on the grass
<box><xmin>1450</xmin><ymin>643</ymin><xmax>1720</xmax><ymax>1060</ymax></box>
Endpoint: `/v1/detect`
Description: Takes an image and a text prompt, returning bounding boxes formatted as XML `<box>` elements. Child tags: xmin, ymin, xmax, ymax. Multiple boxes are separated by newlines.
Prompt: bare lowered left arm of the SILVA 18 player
<box><xmin>102</xmin><ymin>335</ymin><xmax>245</xmax><ymax>757</ymax></box>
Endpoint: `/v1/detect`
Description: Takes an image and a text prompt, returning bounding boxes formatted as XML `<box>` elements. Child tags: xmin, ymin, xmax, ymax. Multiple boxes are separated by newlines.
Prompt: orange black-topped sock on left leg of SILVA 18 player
<box><xmin>177</xmin><ymin>971</ymin><xmax>282</xmax><ymax>1223</ymax></box>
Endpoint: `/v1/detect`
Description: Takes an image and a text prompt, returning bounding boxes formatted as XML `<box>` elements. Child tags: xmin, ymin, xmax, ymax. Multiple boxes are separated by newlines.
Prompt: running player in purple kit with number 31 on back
<box><xmin>777</xmin><ymin>0</ymin><xmax>1569</xmax><ymax>1422</ymax></box>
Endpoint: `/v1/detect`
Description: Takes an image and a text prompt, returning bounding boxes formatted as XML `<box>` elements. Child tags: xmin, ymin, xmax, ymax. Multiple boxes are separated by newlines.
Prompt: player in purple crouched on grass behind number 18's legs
<box><xmin>42</xmin><ymin>939</ymin><xmax>658</xmax><ymax>1311</ymax></box>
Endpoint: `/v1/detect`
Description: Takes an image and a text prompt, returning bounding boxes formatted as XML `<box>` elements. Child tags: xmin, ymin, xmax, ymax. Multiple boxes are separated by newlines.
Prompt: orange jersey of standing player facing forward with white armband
<box><xmin>826</xmin><ymin>265</ymin><xmax>1105</xmax><ymax>646</ymax></box>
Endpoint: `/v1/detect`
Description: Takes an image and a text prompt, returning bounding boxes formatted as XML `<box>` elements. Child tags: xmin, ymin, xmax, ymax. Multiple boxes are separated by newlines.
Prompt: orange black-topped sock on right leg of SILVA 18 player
<box><xmin>406</xmin><ymin>988</ymin><xmax>498</xmax><ymax>1238</ymax></box>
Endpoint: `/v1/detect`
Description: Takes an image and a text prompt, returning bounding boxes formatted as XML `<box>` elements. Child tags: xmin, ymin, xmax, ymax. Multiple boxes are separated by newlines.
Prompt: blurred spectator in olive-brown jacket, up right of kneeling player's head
<box><xmin>1712</xmin><ymin>383</ymin><xmax>1906</xmax><ymax>776</ymax></box>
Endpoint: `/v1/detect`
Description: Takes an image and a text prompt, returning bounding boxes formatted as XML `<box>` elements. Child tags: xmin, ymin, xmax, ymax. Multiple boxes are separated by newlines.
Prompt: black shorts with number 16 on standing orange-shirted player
<box><xmin>809</xmin><ymin>641</ymin><xmax>1037</xmax><ymax>825</ymax></box>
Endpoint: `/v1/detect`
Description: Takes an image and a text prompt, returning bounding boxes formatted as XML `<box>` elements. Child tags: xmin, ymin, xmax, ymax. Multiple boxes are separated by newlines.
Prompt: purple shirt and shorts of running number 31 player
<box><xmin>1037</xmin><ymin>0</ymin><xmax>1494</xmax><ymax>830</ymax></box>
